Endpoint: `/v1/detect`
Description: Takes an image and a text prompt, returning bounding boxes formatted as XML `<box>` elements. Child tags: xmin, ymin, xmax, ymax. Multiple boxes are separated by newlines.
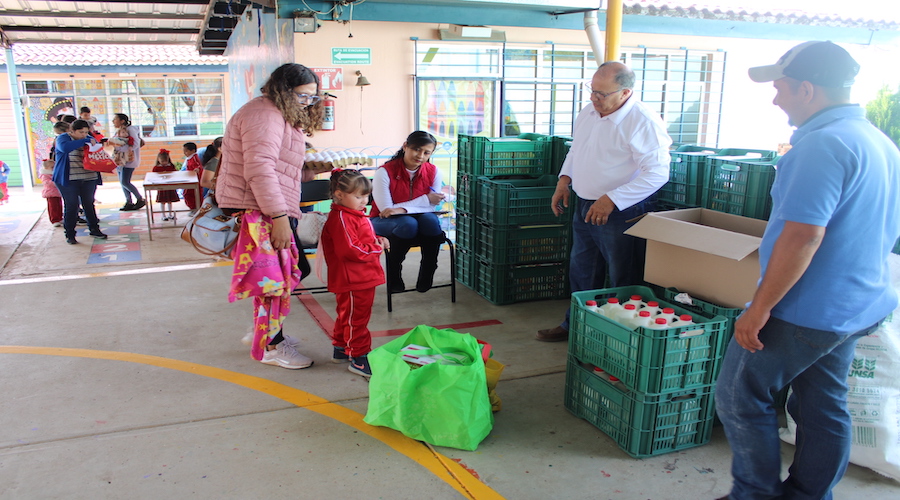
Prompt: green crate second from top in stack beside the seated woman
<box><xmin>478</xmin><ymin>175</ymin><xmax>574</xmax><ymax>226</ymax></box>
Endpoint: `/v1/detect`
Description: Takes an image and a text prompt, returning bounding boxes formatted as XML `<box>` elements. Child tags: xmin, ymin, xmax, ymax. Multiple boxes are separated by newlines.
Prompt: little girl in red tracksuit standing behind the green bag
<box><xmin>320</xmin><ymin>170</ymin><xmax>388</xmax><ymax>377</ymax></box>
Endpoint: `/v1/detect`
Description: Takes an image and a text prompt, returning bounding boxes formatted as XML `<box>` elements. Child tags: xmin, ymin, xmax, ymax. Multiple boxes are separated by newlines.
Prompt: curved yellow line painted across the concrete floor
<box><xmin>0</xmin><ymin>346</ymin><xmax>503</xmax><ymax>500</ymax></box>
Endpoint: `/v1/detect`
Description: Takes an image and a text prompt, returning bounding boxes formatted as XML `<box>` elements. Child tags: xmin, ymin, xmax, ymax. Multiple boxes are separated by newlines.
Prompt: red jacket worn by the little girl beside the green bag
<box><xmin>321</xmin><ymin>203</ymin><xmax>384</xmax><ymax>293</ymax></box>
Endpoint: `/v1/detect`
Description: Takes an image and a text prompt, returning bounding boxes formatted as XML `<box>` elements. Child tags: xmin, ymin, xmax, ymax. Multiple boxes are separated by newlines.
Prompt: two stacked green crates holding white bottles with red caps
<box><xmin>565</xmin><ymin>286</ymin><xmax>728</xmax><ymax>458</ymax></box>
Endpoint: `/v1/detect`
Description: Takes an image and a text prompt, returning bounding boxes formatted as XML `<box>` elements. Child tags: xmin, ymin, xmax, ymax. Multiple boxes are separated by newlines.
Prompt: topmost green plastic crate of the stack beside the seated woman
<box><xmin>457</xmin><ymin>134</ymin><xmax>556</xmax><ymax>177</ymax></box>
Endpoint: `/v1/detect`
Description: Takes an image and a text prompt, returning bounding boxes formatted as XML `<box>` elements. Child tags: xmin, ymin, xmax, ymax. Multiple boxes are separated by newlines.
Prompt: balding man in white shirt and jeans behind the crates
<box><xmin>536</xmin><ymin>61</ymin><xmax>672</xmax><ymax>342</ymax></box>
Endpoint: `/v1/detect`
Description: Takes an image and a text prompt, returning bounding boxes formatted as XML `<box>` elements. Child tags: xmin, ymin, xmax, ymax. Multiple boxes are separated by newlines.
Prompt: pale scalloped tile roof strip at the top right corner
<box><xmin>624</xmin><ymin>0</ymin><xmax>900</xmax><ymax>30</ymax></box>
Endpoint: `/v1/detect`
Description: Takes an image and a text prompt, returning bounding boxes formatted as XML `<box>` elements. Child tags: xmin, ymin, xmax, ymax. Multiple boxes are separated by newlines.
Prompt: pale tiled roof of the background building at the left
<box><xmin>0</xmin><ymin>43</ymin><xmax>228</xmax><ymax>66</ymax></box>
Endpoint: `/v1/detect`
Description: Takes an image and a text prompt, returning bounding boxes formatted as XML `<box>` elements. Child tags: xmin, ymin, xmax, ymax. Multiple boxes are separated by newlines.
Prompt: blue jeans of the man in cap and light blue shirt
<box><xmin>716</xmin><ymin>311</ymin><xmax>878</xmax><ymax>500</ymax></box>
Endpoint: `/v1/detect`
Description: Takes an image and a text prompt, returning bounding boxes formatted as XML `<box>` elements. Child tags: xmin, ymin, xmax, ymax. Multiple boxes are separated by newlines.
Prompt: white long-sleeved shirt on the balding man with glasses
<box><xmin>559</xmin><ymin>94</ymin><xmax>672</xmax><ymax>210</ymax></box>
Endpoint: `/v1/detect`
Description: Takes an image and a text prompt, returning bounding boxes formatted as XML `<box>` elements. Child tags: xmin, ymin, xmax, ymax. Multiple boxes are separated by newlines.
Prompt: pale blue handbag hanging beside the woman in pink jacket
<box><xmin>181</xmin><ymin>192</ymin><xmax>242</xmax><ymax>259</ymax></box>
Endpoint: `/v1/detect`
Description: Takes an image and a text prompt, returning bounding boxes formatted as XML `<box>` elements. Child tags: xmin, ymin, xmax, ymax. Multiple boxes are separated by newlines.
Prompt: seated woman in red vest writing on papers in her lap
<box><xmin>369</xmin><ymin>130</ymin><xmax>444</xmax><ymax>292</ymax></box>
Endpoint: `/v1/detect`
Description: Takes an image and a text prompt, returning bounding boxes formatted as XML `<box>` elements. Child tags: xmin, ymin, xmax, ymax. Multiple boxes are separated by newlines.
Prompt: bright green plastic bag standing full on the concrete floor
<box><xmin>363</xmin><ymin>325</ymin><xmax>494</xmax><ymax>451</ymax></box>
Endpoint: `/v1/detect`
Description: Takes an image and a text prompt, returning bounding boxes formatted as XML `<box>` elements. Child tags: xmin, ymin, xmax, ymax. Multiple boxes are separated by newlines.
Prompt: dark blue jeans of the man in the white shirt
<box><xmin>560</xmin><ymin>197</ymin><xmax>653</xmax><ymax>330</ymax></box>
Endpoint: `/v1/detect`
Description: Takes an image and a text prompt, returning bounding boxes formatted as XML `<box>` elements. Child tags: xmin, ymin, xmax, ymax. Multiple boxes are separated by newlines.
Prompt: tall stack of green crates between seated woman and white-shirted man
<box><xmin>456</xmin><ymin>135</ymin><xmax>571</xmax><ymax>304</ymax></box>
